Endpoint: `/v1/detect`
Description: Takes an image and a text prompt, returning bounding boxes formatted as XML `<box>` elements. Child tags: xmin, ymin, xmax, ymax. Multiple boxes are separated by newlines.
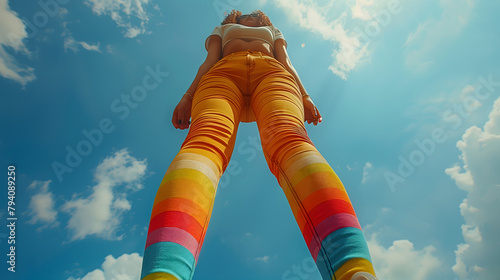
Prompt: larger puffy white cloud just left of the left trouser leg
<box><xmin>62</xmin><ymin>149</ymin><xmax>147</xmax><ymax>241</ymax></box>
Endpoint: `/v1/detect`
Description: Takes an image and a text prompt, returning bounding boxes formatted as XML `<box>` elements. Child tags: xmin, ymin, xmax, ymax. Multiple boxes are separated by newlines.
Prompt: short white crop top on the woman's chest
<box><xmin>205</xmin><ymin>23</ymin><xmax>286</xmax><ymax>50</ymax></box>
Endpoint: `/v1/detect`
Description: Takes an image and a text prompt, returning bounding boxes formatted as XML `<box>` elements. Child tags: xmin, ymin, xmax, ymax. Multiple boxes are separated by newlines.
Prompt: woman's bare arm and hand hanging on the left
<box><xmin>172</xmin><ymin>35</ymin><xmax>222</xmax><ymax>129</ymax></box>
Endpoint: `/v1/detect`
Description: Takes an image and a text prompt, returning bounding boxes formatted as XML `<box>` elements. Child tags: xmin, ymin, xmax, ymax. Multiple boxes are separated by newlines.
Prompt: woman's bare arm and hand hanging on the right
<box><xmin>274</xmin><ymin>39</ymin><xmax>323</xmax><ymax>125</ymax></box>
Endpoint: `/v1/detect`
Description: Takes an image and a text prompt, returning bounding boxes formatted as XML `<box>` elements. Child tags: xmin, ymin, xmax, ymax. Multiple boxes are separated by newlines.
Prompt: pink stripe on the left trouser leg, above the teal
<box><xmin>146</xmin><ymin>227</ymin><xmax>198</xmax><ymax>256</ymax></box>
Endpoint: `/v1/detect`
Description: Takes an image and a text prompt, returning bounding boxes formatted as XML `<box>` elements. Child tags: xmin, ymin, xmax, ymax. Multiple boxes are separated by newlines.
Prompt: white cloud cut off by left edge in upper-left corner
<box><xmin>0</xmin><ymin>0</ymin><xmax>36</xmax><ymax>86</ymax></box>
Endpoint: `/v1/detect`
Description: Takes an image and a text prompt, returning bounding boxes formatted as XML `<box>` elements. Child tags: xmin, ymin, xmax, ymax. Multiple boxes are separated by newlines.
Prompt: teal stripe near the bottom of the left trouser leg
<box><xmin>141</xmin><ymin>242</ymin><xmax>195</xmax><ymax>280</ymax></box>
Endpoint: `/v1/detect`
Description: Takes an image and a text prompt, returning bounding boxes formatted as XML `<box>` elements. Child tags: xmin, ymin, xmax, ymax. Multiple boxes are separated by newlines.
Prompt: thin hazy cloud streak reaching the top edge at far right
<box><xmin>405</xmin><ymin>0</ymin><xmax>475</xmax><ymax>71</ymax></box>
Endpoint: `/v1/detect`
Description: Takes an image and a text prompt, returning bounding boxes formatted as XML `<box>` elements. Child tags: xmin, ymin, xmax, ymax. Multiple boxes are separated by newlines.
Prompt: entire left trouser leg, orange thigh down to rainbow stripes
<box><xmin>141</xmin><ymin>75</ymin><xmax>243</xmax><ymax>280</ymax></box>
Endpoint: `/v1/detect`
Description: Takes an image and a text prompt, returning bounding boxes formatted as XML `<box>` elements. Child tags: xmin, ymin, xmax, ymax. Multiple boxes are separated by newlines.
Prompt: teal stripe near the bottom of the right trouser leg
<box><xmin>316</xmin><ymin>227</ymin><xmax>371</xmax><ymax>279</ymax></box>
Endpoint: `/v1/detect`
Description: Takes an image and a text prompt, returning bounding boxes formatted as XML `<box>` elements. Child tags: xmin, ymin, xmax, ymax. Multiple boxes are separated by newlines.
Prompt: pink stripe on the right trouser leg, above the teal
<box><xmin>307</xmin><ymin>213</ymin><xmax>361</xmax><ymax>261</ymax></box>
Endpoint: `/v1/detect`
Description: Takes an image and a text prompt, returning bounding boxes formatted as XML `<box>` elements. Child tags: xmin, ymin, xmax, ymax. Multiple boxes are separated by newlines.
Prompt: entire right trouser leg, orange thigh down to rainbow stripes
<box><xmin>252</xmin><ymin>76</ymin><xmax>375</xmax><ymax>280</ymax></box>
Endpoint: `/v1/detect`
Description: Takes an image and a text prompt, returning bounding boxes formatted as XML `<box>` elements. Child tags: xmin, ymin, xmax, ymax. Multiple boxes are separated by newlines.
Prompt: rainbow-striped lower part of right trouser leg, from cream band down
<box><xmin>279</xmin><ymin>148</ymin><xmax>375</xmax><ymax>280</ymax></box>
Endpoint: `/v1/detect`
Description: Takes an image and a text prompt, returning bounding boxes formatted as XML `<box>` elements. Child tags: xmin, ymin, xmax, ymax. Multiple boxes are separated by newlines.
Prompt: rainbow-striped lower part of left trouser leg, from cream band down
<box><xmin>141</xmin><ymin>151</ymin><xmax>219</xmax><ymax>280</ymax></box>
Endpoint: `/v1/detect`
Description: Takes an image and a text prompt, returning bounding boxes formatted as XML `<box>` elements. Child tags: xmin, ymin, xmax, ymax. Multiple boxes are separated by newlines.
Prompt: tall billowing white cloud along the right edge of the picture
<box><xmin>445</xmin><ymin>98</ymin><xmax>500</xmax><ymax>280</ymax></box>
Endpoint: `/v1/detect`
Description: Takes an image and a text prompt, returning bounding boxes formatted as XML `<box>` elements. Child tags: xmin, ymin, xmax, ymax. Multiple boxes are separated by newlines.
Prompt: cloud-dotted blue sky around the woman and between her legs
<box><xmin>0</xmin><ymin>0</ymin><xmax>500</xmax><ymax>280</ymax></box>
